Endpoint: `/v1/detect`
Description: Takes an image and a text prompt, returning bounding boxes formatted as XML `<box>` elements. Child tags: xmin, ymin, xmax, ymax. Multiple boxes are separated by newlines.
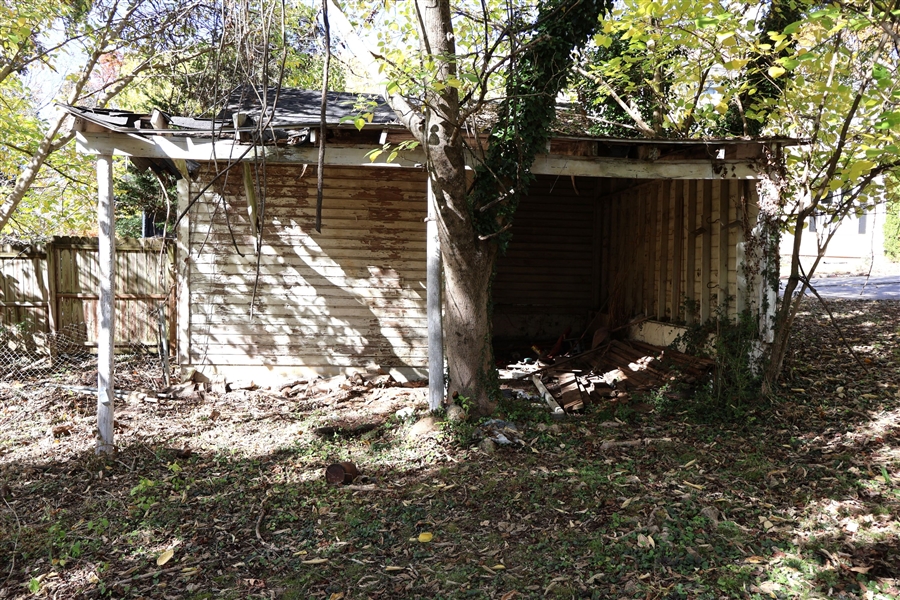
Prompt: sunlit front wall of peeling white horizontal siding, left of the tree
<box><xmin>180</xmin><ymin>166</ymin><xmax>427</xmax><ymax>376</ymax></box>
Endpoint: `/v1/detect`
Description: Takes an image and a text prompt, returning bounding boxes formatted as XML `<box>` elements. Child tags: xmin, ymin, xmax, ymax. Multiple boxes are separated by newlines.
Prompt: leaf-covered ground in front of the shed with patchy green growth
<box><xmin>0</xmin><ymin>301</ymin><xmax>900</xmax><ymax>600</ymax></box>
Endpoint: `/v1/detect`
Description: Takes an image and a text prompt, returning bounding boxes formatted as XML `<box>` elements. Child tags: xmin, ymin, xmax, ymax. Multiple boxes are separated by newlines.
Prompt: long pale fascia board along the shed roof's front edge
<box><xmin>76</xmin><ymin>132</ymin><xmax>763</xmax><ymax>179</ymax></box>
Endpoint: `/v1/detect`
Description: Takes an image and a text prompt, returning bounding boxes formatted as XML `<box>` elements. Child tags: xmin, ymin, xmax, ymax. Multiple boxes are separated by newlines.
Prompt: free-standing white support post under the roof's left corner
<box><xmin>97</xmin><ymin>154</ymin><xmax>116</xmax><ymax>454</ymax></box>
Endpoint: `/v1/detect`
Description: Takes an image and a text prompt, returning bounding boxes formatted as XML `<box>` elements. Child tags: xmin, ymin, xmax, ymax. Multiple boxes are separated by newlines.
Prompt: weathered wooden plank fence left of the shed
<box><xmin>0</xmin><ymin>237</ymin><xmax>176</xmax><ymax>346</ymax></box>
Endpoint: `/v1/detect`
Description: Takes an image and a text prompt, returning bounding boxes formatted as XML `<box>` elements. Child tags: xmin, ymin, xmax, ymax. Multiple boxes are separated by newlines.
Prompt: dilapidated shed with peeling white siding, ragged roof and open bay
<box><xmin>67</xmin><ymin>90</ymin><xmax>785</xmax><ymax>390</ymax></box>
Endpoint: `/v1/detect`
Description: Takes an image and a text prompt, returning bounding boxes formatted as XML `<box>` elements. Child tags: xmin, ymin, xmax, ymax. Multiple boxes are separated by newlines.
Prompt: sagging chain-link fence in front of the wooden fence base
<box><xmin>0</xmin><ymin>324</ymin><xmax>168</xmax><ymax>390</ymax></box>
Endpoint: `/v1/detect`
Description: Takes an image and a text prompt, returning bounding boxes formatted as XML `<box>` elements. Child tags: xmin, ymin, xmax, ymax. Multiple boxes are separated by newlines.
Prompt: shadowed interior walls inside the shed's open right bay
<box><xmin>494</xmin><ymin>177</ymin><xmax>758</xmax><ymax>340</ymax></box>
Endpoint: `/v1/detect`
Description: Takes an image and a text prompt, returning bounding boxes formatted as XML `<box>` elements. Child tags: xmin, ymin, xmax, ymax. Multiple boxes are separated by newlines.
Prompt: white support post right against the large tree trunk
<box><xmin>425</xmin><ymin>177</ymin><xmax>444</xmax><ymax>411</ymax></box>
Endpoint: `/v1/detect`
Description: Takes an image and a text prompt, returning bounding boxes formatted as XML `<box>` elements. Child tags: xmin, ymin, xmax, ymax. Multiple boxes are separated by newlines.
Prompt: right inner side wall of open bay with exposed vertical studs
<box><xmin>599</xmin><ymin>180</ymin><xmax>759</xmax><ymax>323</ymax></box>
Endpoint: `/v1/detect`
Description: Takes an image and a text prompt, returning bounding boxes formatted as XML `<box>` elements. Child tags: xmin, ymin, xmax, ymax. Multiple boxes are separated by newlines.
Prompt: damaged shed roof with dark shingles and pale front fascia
<box><xmin>63</xmin><ymin>87</ymin><xmax>797</xmax><ymax>179</ymax></box>
